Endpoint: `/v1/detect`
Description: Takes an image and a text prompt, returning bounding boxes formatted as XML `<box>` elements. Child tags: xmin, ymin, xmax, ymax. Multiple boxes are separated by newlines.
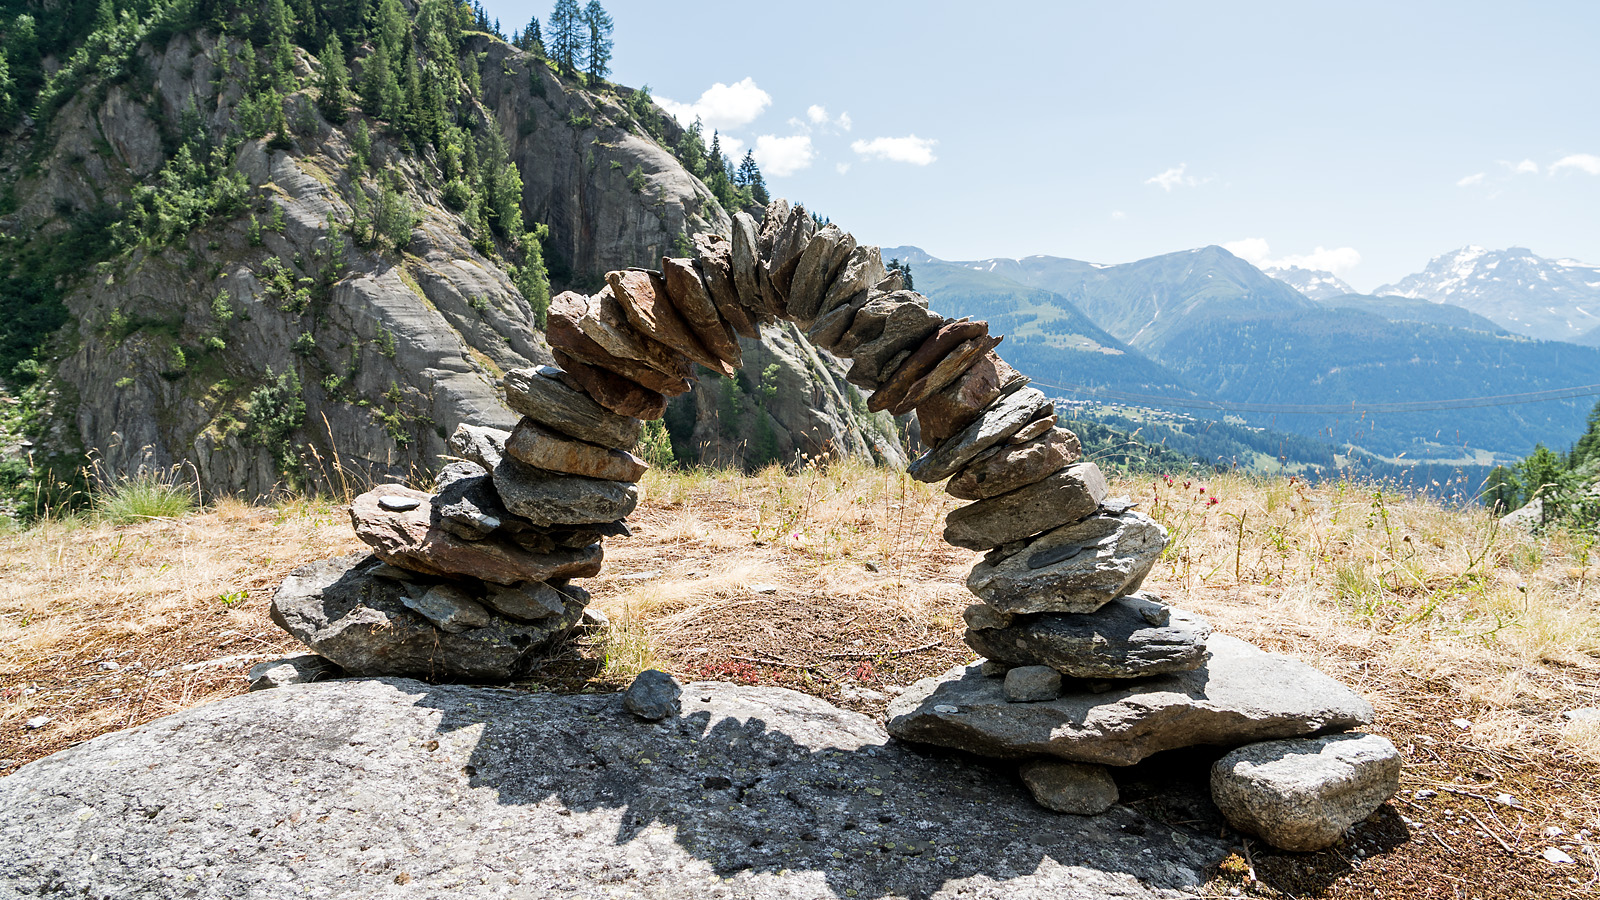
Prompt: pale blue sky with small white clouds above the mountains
<box><xmin>486</xmin><ymin>0</ymin><xmax>1600</xmax><ymax>290</ymax></box>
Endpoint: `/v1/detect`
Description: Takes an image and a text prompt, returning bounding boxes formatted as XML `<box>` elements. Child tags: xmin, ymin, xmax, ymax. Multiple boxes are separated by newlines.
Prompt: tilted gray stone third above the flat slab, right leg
<box><xmin>944</xmin><ymin>463</ymin><xmax>1109</xmax><ymax>550</ymax></box>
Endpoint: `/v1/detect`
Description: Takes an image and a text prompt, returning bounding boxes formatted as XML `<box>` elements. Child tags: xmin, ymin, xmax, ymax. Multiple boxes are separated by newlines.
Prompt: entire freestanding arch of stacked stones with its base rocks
<box><xmin>274</xmin><ymin>200</ymin><xmax>1398</xmax><ymax>849</ymax></box>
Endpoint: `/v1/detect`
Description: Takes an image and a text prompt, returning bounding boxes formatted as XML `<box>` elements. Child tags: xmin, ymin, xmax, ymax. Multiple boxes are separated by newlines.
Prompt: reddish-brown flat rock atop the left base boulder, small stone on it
<box><xmin>350</xmin><ymin>483</ymin><xmax>602</xmax><ymax>585</ymax></box>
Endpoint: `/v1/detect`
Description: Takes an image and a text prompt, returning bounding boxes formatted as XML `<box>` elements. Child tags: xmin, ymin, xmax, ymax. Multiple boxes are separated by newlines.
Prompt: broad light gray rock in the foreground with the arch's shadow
<box><xmin>0</xmin><ymin>679</ymin><xmax>1227</xmax><ymax>900</ymax></box>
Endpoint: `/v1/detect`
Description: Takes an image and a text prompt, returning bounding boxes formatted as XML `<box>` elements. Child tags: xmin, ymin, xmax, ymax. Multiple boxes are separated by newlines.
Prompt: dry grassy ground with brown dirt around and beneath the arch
<box><xmin>0</xmin><ymin>469</ymin><xmax>1600</xmax><ymax>900</ymax></box>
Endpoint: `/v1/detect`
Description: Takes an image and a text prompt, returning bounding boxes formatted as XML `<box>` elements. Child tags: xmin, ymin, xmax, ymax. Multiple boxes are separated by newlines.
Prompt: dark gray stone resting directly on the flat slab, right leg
<box><xmin>966</xmin><ymin>594</ymin><xmax>1211</xmax><ymax>679</ymax></box>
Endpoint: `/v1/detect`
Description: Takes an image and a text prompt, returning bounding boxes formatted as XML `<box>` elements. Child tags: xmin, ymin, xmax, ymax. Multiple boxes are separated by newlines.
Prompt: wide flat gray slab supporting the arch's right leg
<box><xmin>888</xmin><ymin>634</ymin><xmax>1373</xmax><ymax>765</ymax></box>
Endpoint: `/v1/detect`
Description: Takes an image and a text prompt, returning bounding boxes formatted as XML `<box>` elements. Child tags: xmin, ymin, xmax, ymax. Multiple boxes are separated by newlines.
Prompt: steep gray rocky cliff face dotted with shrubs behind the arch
<box><xmin>6</xmin><ymin>17</ymin><xmax>898</xmax><ymax>496</ymax></box>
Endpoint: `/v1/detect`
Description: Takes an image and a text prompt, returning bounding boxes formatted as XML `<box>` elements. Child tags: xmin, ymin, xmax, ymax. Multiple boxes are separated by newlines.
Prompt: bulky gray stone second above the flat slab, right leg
<box><xmin>966</xmin><ymin>511</ymin><xmax>1166</xmax><ymax>613</ymax></box>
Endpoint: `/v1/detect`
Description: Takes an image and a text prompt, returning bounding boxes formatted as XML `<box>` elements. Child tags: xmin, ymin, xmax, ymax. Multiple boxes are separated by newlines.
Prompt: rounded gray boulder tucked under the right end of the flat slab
<box><xmin>1211</xmin><ymin>733</ymin><xmax>1400</xmax><ymax>850</ymax></box>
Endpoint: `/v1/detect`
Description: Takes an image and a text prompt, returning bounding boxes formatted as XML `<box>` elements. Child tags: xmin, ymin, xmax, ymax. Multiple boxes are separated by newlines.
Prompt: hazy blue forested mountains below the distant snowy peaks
<box><xmin>885</xmin><ymin>247</ymin><xmax>1600</xmax><ymax>466</ymax></box>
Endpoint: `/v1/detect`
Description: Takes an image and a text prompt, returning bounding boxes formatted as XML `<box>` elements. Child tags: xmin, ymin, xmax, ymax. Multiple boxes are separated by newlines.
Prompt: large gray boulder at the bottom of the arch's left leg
<box><xmin>272</xmin><ymin>554</ymin><xmax>589</xmax><ymax>681</ymax></box>
